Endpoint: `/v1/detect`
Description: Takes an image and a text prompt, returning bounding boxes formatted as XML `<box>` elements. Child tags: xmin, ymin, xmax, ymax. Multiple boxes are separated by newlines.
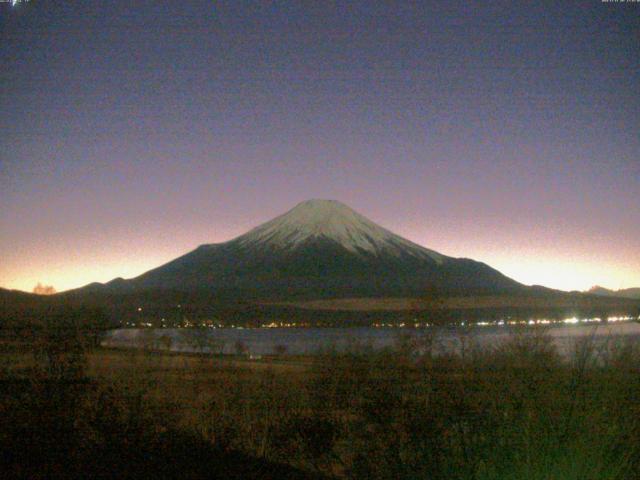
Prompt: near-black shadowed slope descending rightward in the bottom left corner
<box><xmin>0</xmin><ymin>376</ymin><xmax>327</xmax><ymax>480</ymax></box>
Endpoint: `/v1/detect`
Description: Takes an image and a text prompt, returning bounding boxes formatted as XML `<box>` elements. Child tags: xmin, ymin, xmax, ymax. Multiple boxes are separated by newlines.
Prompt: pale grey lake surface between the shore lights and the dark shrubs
<box><xmin>103</xmin><ymin>322</ymin><xmax>640</xmax><ymax>356</ymax></box>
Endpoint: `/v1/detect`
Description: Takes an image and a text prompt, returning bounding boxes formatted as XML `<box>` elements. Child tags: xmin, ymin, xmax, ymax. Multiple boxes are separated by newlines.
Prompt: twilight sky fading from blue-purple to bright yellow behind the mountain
<box><xmin>0</xmin><ymin>0</ymin><xmax>640</xmax><ymax>291</ymax></box>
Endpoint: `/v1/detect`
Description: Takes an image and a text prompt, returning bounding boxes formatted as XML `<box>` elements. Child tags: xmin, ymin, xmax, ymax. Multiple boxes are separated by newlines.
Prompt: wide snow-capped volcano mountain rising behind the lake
<box><xmin>81</xmin><ymin>200</ymin><xmax>524</xmax><ymax>300</ymax></box>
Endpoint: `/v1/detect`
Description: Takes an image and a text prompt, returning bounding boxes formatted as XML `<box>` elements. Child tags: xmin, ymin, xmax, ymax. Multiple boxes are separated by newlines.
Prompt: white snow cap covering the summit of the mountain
<box><xmin>236</xmin><ymin>200</ymin><xmax>444</xmax><ymax>263</ymax></box>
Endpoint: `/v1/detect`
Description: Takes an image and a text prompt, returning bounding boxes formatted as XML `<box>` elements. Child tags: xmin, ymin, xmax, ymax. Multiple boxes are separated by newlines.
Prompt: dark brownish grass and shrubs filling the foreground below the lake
<box><xmin>0</xmin><ymin>312</ymin><xmax>640</xmax><ymax>480</ymax></box>
